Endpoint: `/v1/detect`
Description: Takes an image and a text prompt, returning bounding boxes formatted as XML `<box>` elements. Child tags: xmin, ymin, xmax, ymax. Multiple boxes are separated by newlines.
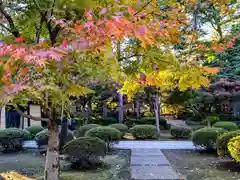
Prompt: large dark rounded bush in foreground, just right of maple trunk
<box><xmin>63</xmin><ymin>137</ymin><xmax>107</xmax><ymax>168</ymax></box>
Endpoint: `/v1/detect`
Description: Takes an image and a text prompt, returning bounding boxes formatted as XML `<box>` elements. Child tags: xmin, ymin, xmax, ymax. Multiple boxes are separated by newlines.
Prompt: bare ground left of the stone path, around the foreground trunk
<box><xmin>0</xmin><ymin>150</ymin><xmax>131</xmax><ymax>180</ymax></box>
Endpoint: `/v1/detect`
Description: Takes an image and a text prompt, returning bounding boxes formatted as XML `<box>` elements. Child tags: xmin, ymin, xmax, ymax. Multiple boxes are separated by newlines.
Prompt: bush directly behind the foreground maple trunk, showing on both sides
<box><xmin>34</xmin><ymin>129</ymin><xmax>73</xmax><ymax>146</ymax></box>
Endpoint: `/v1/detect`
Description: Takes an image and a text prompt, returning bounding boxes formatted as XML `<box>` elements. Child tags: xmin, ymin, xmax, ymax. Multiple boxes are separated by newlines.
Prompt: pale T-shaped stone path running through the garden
<box><xmin>114</xmin><ymin>141</ymin><xmax>202</xmax><ymax>180</ymax></box>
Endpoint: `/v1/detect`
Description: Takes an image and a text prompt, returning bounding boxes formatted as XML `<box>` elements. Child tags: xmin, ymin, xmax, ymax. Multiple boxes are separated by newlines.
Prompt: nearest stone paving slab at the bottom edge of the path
<box><xmin>131</xmin><ymin>166</ymin><xmax>180</xmax><ymax>180</ymax></box>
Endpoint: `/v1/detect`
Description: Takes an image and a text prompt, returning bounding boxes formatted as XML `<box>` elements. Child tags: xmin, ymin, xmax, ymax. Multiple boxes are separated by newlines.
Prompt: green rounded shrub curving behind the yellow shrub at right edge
<box><xmin>216</xmin><ymin>130</ymin><xmax>240</xmax><ymax>156</ymax></box>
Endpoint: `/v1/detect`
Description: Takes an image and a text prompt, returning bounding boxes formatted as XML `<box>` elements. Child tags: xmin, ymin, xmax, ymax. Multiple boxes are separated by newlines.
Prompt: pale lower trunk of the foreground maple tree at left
<box><xmin>44</xmin><ymin>109</ymin><xmax>59</xmax><ymax>180</ymax></box>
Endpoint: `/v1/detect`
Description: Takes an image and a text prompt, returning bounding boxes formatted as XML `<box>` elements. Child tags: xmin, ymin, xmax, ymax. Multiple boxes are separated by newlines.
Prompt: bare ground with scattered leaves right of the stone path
<box><xmin>163</xmin><ymin>150</ymin><xmax>240</xmax><ymax>180</ymax></box>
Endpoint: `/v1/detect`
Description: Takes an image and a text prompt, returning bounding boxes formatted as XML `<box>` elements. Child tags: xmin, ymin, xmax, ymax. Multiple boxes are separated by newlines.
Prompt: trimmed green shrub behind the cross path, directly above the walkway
<box><xmin>130</xmin><ymin>125</ymin><xmax>157</xmax><ymax>139</ymax></box>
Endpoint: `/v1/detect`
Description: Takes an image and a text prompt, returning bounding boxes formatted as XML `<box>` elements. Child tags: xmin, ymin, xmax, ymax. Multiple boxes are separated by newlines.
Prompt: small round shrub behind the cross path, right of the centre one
<box><xmin>170</xmin><ymin>126</ymin><xmax>192</xmax><ymax>139</ymax></box>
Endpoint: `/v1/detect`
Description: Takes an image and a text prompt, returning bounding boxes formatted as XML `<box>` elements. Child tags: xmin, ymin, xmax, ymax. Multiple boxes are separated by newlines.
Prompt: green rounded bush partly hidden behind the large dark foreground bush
<box><xmin>85</xmin><ymin>126</ymin><xmax>121</xmax><ymax>148</ymax></box>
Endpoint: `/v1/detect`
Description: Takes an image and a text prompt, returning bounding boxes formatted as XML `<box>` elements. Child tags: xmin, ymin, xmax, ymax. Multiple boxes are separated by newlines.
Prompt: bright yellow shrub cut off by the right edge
<box><xmin>228</xmin><ymin>136</ymin><xmax>240</xmax><ymax>162</ymax></box>
